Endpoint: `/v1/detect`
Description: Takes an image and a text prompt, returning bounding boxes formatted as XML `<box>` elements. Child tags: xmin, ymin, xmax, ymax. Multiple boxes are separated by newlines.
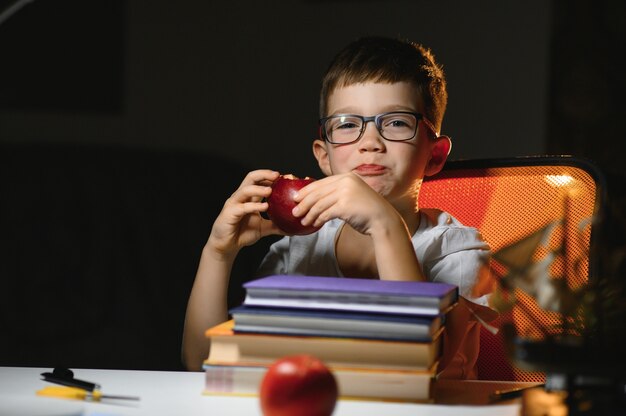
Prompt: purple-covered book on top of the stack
<box><xmin>244</xmin><ymin>275</ymin><xmax>459</xmax><ymax>316</ymax></box>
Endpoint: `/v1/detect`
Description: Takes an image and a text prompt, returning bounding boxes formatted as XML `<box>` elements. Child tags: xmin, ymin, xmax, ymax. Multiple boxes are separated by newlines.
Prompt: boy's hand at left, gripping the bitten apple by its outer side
<box><xmin>207</xmin><ymin>169</ymin><xmax>284</xmax><ymax>258</ymax></box>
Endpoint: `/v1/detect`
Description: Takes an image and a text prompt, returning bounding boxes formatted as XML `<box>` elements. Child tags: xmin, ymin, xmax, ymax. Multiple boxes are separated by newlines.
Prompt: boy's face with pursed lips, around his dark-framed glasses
<box><xmin>313</xmin><ymin>82</ymin><xmax>449</xmax><ymax>204</ymax></box>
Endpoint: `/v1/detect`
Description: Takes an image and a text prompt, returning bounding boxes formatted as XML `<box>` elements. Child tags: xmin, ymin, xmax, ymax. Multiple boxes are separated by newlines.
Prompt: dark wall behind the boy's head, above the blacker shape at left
<box><xmin>0</xmin><ymin>0</ymin><xmax>626</xmax><ymax>176</ymax></box>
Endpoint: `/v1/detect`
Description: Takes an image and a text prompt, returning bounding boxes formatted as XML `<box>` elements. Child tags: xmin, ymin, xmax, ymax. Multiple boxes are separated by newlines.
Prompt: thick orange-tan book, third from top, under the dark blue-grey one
<box><xmin>205</xmin><ymin>319</ymin><xmax>443</xmax><ymax>370</ymax></box>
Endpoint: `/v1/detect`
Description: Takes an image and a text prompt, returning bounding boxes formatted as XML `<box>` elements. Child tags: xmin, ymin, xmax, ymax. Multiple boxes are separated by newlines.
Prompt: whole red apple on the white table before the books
<box><xmin>259</xmin><ymin>354</ymin><xmax>338</xmax><ymax>416</ymax></box>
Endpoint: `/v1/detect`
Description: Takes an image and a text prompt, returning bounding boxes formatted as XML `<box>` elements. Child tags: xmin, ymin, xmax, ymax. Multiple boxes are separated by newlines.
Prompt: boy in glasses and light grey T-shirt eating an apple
<box><xmin>183</xmin><ymin>37</ymin><xmax>491</xmax><ymax>378</ymax></box>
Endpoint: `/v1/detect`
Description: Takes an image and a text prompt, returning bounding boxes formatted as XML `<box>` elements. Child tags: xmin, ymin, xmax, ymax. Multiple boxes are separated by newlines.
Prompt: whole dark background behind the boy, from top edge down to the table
<box><xmin>0</xmin><ymin>0</ymin><xmax>626</xmax><ymax>369</ymax></box>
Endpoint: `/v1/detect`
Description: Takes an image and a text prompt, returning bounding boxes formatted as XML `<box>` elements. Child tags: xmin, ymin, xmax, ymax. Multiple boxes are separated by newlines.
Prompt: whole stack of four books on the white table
<box><xmin>204</xmin><ymin>276</ymin><xmax>458</xmax><ymax>401</ymax></box>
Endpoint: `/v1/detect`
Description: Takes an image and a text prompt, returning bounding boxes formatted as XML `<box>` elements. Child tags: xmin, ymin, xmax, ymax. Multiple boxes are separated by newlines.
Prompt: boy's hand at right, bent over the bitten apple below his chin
<box><xmin>293</xmin><ymin>173</ymin><xmax>398</xmax><ymax>235</ymax></box>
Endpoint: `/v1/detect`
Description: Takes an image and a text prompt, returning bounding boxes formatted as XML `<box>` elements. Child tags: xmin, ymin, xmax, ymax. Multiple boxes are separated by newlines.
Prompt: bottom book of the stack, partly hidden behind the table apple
<box><xmin>203</xmin><ymin>363</ymin><xmax>437</xmax><ymax>402</ymax></box>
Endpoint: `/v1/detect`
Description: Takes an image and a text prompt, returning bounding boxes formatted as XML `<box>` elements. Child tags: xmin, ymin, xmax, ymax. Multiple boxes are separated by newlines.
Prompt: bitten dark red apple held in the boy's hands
<box><xmin>267</xmin><ymin>175</ymin><xmax>319</xmax><ymax>235</ymax></box>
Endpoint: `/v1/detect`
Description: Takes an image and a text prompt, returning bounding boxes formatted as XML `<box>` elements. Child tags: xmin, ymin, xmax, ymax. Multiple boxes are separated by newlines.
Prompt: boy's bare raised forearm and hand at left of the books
<box><xmin>182</xmin><ymin>170</ymin><xmax>281</xmax><ymax>371</ymax></box>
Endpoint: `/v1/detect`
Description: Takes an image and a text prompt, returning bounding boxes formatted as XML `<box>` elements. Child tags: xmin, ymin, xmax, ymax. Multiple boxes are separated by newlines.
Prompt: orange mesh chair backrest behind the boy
<box><xmin>420</xmin><ymin>156</ymin><xmax>599</xmax><ymax>382</ymax></box>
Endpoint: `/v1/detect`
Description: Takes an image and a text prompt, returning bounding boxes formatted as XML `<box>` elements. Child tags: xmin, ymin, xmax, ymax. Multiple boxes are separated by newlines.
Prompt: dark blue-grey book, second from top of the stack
<box><xmin>230</xmin><ymin>305</ymin><xmax>443</xmax><ymax>342</ymax></box>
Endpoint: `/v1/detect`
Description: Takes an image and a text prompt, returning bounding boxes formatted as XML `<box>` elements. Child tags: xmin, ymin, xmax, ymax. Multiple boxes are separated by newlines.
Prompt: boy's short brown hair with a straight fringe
<box><xmin>320</xmin><ymin>37</ymin><xmax>448</xmax><ymax>130</ymax></box>
